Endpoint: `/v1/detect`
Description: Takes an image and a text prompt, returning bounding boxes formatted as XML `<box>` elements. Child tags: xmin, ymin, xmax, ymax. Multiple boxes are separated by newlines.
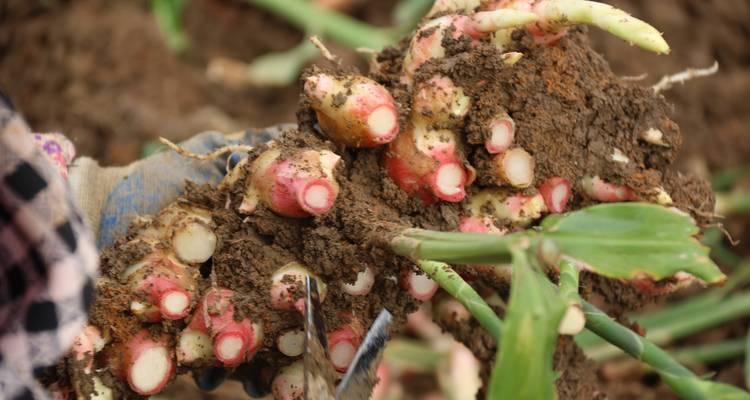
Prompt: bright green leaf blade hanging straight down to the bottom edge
<box><xmin>487</xmin><ymin>251</ymin><xmax>566</xmax><ymax>400</ymax></box>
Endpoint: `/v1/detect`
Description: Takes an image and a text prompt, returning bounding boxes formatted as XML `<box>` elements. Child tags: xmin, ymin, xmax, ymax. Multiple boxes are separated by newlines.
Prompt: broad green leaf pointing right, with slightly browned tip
<box><xmin>541</xmin><ymin>203</ymin><xmax>726</xmax><ymax>283</ymax></box>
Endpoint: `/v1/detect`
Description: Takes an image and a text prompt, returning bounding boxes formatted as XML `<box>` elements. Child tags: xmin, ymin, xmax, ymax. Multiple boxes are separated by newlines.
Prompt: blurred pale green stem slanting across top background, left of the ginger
<box><xmin>248</xmin><ymin>0</ymin><xmax>398</xmax><ymax>50</ymax></box>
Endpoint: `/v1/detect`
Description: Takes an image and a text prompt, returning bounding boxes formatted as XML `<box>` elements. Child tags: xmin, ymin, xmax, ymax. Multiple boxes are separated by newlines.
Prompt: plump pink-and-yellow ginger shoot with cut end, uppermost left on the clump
<box><xmin>305</xmin><ymin>73</ymin><xmax>399</xmax><ymax>148</ymax></box>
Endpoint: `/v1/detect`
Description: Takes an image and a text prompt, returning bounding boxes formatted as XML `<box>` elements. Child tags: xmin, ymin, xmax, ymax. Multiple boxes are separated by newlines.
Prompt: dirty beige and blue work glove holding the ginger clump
<box><xmin>69</xmin><ymin>124</ymin><xmax>294</xmax><ymax>250</ymax></box>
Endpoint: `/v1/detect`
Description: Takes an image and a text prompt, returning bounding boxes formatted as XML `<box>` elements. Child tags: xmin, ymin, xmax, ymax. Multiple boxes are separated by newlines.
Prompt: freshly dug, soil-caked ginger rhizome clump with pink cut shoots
<box><xmin>60</xmin><ymin>0</ymin><xmax>702</xmax><ymax>399</ymax></box>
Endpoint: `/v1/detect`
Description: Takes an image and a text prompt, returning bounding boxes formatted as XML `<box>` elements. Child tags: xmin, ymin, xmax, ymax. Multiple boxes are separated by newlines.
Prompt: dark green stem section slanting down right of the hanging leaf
<box><xmin>583</xmin><ymin>302</ymin><xmax>694</xmax><ymax>377</ymax></box>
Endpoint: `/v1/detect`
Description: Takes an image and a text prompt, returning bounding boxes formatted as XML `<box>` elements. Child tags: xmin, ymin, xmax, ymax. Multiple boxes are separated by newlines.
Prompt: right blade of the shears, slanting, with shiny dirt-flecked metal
<box><xmin>336</xmin><ymin>310</ymin><xmax>393</xmax><ymax>400</ymax></box>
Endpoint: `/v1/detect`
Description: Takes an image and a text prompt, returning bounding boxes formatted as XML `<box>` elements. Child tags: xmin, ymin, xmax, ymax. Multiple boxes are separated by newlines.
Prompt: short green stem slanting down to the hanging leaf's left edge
<box><xmin>417</xmin><ymin>260</ymin><xmax>503</xmax><ymax>340</ymax></box>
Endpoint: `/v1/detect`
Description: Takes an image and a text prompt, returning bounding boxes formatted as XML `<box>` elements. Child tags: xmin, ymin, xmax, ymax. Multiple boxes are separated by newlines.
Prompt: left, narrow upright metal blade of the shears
<box><xmin>304</xmin><ymin>276</ymin><xmax>336</xmax><ymax>400</ymax></box>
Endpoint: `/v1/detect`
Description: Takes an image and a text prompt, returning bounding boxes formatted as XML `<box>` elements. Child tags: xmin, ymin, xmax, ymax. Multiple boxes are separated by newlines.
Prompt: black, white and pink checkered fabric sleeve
<box><xmin>0</xmin><ymin>102</ymin><xmax>98</xmax><ymax>399</ymax></box>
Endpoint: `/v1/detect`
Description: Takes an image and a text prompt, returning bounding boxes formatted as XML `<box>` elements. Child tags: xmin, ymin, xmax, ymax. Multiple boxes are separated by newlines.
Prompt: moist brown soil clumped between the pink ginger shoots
<box><xmin>79</xmin><ymin>30</ymin><xmax>713</xmax><ymax>399</ymax></box>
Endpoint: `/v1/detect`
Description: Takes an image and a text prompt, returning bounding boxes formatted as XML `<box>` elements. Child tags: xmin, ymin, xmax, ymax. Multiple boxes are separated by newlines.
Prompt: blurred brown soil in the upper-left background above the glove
<box><xmin>0</xmin><ymin>0</ymin><xmax>324</xmax><ymax>164</ymax></box>
